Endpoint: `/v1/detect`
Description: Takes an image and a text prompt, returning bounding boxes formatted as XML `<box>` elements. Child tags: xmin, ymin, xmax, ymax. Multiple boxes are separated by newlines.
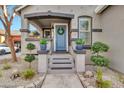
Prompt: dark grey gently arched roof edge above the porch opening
<box><xmin>24</xmin><ymin>11</ymin><xmax>74</xmax><ymax>19</ymax></box>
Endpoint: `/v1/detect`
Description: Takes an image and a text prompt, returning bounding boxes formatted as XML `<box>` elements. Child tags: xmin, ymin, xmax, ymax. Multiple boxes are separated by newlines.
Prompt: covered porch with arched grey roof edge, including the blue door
<box><xmin>21</xmin><ymin>11</ymin><xmax>74</xmax><ymax>53</ymax></box>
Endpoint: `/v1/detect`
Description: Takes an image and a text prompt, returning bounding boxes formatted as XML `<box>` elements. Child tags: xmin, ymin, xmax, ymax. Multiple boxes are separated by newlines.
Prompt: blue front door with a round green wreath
<box><xmin>55</xmin><ymin>25</ymin><xmax>66</xmax><ymax>51</ymax></box>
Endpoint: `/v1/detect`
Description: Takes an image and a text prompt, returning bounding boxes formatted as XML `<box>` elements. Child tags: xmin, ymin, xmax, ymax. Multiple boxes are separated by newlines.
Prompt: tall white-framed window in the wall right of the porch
<box><xmin>78</xmin><ymin>16</ymin><xmax>92</xmax><ymax>45</ymax></box>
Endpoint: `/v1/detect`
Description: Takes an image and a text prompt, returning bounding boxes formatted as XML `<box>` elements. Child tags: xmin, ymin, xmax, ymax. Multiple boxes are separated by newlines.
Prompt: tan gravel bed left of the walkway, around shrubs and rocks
<box><xmin>0</xmin><ymin>58</ymin><xmax>44</xmax><ymax>88</ymax></box>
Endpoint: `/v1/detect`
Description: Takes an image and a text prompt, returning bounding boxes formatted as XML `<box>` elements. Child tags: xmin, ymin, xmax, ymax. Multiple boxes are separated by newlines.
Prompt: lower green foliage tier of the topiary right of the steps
<box><xmin>91</xmin><ymin>55</ymin><xmax>109</xmax><ymax>66</ymax></box>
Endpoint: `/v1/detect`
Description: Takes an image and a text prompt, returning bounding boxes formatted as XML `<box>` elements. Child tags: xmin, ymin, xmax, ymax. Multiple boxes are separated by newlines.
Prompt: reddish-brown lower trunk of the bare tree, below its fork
<box><xmin>7</xmin><ymin>36</ymin><xmax>17</xmax><ymax>62</ymax></box>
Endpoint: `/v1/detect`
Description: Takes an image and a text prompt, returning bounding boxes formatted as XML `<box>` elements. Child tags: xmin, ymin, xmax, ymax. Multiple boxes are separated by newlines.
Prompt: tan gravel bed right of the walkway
<box><xmin>78</xmin><ymin>65</ymin><xmax>124</xmax><ymax>88</ymax></box>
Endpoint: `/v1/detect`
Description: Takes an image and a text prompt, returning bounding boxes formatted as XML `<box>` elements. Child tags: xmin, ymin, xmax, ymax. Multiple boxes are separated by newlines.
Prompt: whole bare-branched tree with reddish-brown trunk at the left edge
<box><xmin>0</xmin><ymin>5</ymin><xmax>17</xmax><ymax>62</ymax></box>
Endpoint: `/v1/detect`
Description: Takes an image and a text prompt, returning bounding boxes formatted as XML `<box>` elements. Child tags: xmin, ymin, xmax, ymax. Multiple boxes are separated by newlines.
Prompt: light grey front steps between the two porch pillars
<box><xmin>48</xmin><ymin>54</ymin><xmax>75</xmax><ymax>73</ymax></box>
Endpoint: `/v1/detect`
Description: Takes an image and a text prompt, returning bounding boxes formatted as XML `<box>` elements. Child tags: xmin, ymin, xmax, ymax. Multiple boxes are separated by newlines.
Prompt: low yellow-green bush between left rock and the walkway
<box><xmin>21</xmin><ymin>69</ymin><xmax>35</xmax><ymax>79</ymax></box>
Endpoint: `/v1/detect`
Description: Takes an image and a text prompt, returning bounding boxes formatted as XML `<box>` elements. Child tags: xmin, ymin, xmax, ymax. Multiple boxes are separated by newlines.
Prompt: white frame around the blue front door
<box><xmin>54</xmin><ymin>23</ymin><xmax>68</xmax><ymax>52</ymax></box>
